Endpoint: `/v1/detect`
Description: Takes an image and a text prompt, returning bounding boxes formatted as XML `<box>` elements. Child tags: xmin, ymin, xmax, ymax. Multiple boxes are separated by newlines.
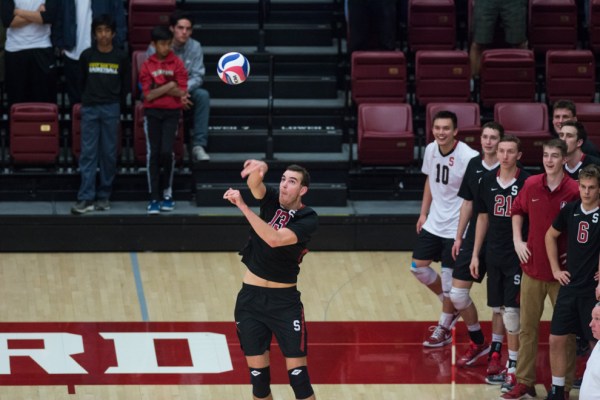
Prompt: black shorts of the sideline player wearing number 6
<box><xmin>550</xmin><ymin>287</ymin><xmax>597</xmax><ymax>340</ymax></box>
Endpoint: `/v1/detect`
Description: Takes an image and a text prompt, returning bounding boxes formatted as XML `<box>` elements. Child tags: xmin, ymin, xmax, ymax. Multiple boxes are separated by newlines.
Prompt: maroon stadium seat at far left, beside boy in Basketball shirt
<box><xmin>10</xmin><ymin>103</ymin><xmax>59</xmax><ymax>165</ymax></box>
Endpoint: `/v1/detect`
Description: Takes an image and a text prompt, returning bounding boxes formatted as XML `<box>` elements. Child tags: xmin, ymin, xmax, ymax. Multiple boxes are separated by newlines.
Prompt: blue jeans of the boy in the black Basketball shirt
<box><xmin>77</xmin><ymin>103</ymin><xmax>121</xmax><ymax>201</ymax></box>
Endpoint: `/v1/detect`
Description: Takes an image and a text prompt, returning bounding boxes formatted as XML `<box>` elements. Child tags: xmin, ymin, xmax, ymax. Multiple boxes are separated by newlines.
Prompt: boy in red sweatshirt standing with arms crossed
<box><xmin>140</xmin><ymin>26</ymin><xmax>188</xmax><ymax>214</ymax></box>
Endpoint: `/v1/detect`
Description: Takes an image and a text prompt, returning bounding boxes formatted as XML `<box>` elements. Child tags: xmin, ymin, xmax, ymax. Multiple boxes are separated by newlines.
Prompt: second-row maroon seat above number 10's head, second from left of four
<box><xmin>415</xmin><ymin>50</ymin><xmax>471</xmax><ymax>105</ymax></box>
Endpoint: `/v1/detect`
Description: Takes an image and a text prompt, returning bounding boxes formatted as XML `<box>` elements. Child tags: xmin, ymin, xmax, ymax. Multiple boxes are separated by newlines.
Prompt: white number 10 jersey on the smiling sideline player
<box><xmin>421</xmin><ymin>141</ymin><xmax>479</xmax><ymax>239</ymax></box>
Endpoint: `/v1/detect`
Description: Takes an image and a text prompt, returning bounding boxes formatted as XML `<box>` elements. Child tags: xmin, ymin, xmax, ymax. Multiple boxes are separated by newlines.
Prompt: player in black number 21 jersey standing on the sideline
<box><xmin>470</xmin><ymin>135</ymin><xmax>529</xmax><ymax>393</ymax></box>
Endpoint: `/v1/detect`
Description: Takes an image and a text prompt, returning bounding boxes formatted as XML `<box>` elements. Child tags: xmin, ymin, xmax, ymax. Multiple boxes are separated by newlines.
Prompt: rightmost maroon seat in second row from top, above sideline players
<box><xmin>546</xmin><ymin>50</ymin><xmax>596</xmax><ymax>104</ymax></box>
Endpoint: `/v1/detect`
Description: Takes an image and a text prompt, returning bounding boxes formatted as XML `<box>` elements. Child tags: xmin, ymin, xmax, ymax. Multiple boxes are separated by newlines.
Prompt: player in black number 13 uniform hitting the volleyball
<box><xmin>223</xmin><ymin>160</ymin><xmax>318</xmax><ymax>400</ymax></box>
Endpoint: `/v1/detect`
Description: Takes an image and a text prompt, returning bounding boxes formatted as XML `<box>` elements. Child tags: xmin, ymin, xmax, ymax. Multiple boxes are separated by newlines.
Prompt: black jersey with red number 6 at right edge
<box><xmin>552</xmin><ymin>200</ymin><xmax>600</xmax><ymax>295</ymax></box>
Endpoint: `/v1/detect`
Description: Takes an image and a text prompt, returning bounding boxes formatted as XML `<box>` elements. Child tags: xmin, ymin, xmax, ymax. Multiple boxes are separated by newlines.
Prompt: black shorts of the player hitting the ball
<box><xmin>235</xmin><ymin>283</ymin><xmax>307</xmax><ymax>358</ymax></box>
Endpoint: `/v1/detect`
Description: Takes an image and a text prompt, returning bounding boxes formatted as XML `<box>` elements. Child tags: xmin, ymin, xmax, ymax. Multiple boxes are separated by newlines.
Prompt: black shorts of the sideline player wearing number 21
<box><xmin>486</xmin><ymin>254</ymin><xmax>523</xmax><ymax>308</ymax></box>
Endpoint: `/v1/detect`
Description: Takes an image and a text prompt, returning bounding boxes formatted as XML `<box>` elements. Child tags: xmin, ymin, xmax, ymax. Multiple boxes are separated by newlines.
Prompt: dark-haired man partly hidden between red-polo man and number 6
<box><xmin>558</xmin><ymin>121</ymin><xmax>600</xmax><ymax>180</ymax></box>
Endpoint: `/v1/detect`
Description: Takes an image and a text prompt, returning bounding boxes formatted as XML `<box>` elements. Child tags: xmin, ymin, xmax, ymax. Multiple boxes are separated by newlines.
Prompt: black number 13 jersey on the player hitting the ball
<box><xmin>240</xmin><ymin>186</ymin><xmax>318</xmax><ymax>283</ymax></box>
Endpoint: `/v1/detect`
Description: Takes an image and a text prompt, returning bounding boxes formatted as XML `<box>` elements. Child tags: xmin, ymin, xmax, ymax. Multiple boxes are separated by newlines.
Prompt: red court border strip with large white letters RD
<box><xmin>0</xmin><ymin>322</ymin><xmax>550</xmax><ymax>391</ymax></box>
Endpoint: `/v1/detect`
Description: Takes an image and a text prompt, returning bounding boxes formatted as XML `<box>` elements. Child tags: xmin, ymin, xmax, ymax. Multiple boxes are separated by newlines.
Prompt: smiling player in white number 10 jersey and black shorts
<box><xmin>411</xmin><ymin>111</ymin><xmax>478</xmax><ymax>347</ymax></box>
